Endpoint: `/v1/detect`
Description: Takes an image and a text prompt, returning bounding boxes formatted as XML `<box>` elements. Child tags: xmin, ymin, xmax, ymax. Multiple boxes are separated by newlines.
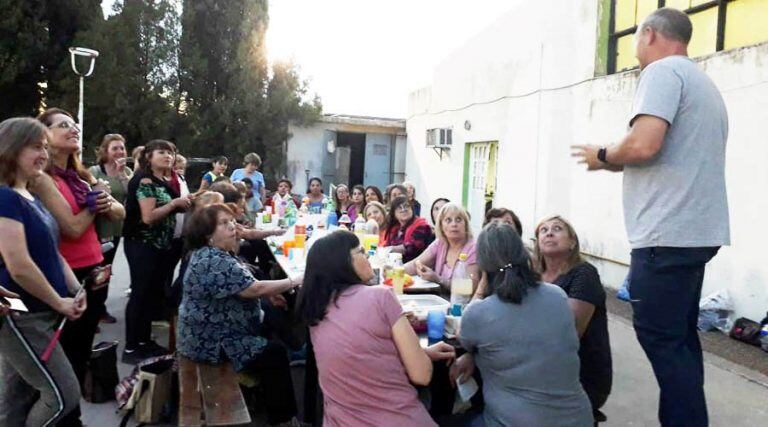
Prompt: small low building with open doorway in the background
<box><xmin>283</xmin><ymin>114</ymin><xmax>406</xmax><ymax>194</ymax></box>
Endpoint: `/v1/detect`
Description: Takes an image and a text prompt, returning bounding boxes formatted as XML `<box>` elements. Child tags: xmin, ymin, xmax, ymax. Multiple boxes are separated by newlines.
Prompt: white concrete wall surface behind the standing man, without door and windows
<box><xmin>406</xmin><ymin>0</ymin><xmax>768</xmax><ymax>320</ymax></box>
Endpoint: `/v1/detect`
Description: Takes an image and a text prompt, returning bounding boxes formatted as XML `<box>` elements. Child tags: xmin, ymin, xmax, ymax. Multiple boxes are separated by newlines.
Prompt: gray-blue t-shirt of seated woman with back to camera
<box><xmin>460</xmin><ymin>283</ymin><xmax>593</xmax><ymax>427</ymax></box>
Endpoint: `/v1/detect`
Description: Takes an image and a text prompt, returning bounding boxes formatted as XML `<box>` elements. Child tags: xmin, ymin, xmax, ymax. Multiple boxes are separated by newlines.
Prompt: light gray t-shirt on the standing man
<box><xmin>624</xmin><ymin>56</ymin><xmax>730</xmax><ymax>248</ymax></box>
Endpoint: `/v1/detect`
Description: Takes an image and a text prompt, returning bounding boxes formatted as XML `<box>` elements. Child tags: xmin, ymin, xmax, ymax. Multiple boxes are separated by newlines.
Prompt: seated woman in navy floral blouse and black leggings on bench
<box><xmin>177</xmin><ymin>204</ymin><xmax>299</xmax><ymax>425</ymax></box>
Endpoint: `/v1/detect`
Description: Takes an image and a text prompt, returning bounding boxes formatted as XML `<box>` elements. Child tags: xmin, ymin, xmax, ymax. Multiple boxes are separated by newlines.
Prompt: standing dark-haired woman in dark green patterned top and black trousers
<box><xmin>123</xmin><ymin>139</ymin><xmax>190</xmax><ymax>363</ymax></box>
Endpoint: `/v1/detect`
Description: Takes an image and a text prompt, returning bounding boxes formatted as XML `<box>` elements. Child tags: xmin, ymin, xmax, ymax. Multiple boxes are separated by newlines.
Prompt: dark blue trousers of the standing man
<box><xmin>629</xmin><ymin>247</ymin><xmax>719</xmax><ymax>426</ymax></box>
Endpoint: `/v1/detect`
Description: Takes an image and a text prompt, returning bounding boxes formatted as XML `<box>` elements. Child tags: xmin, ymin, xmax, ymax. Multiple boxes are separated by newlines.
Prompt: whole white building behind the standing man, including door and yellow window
<box><xmin>406</xmin><ymin>0</ymin><xmax>768</xmax><ymax>319</ymax></box>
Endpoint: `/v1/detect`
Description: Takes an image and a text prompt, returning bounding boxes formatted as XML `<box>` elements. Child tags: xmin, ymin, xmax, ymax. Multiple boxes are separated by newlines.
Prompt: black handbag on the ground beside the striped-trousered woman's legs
<box><xmin>83</xmin><ymin>341</ymin><xmax>119</xmax><ymax>403</ymax></box>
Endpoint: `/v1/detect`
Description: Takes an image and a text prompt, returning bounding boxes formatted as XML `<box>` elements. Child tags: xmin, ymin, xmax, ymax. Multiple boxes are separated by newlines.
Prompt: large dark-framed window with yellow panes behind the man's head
<box><xmin>606</xmin><ymin>0</ymin><xmax>768</xmax><ymax>73</ymax></box>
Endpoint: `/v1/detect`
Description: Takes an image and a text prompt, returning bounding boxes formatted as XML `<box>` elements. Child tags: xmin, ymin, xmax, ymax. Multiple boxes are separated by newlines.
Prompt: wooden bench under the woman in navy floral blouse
<box><xmin>179</xmin><ymin>356</ymin><xmax>251</xmax><ymax>427</ymax></box>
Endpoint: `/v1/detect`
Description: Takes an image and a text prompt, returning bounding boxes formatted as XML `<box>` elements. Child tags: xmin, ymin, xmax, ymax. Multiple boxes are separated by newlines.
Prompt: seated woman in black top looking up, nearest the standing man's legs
<box><xmin>534</xmin><ymin>216</ymin><xmax>613</xmax><ymax>419</ymax></box>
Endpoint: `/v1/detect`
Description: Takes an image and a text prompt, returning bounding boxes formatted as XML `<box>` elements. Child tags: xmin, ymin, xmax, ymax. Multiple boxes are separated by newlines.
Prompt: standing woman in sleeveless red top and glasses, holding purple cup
<box><xmin>37</xmin><ymin>108</ymin><xmax>125</xmax><ymax>425</ymax></box>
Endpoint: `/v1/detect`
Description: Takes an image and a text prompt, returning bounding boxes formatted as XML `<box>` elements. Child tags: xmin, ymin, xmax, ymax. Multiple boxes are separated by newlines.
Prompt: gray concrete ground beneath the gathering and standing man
<box><xmin>78</xmin><ymin>250</ymin><xmax>768</xmax><ymax>427</ymax></box>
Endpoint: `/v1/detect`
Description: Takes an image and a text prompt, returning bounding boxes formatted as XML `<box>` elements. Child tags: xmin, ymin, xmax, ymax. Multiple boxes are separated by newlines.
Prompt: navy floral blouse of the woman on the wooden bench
<box><xmin>177</xmin><ymin>246</ymin><xmax>267</xmax><ymax>371</ymax></box>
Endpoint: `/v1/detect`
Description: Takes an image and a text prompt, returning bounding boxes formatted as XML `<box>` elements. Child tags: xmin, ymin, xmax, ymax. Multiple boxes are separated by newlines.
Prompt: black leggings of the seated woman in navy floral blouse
<box><xmin>245</xmin><ymin>341</ymin><xmax>298</xmax><ymax>425</ymax></box>
